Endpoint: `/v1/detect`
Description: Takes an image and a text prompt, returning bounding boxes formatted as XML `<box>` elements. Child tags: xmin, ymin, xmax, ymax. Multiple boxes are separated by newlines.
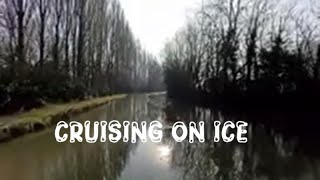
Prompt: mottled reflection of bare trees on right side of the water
<box><xmin>166</xmin><ymin>102</ymin><xmax>320</xmax><ymax>180</ymax></box>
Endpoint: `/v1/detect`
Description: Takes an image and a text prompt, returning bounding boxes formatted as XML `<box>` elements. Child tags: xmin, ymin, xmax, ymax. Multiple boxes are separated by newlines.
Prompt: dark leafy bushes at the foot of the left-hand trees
<box><xmin>0</xmin><ymin>65</ymin><xmax>87</xmax><ymax>114</ymax></box>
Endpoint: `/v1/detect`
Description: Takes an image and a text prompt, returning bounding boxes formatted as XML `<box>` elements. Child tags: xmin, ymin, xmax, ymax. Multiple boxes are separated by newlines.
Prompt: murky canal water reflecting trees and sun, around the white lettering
<box><xmin>0</xmin><ymin>95</ymin><xmax>320</xmax><ymax>180</ymax></box>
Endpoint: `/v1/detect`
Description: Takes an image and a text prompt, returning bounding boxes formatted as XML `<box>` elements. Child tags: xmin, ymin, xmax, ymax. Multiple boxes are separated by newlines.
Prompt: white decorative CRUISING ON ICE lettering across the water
<box><xmin>55</xmin><ymin>120</ymin><xmax>248</xmax><ymax>143</ymax></box>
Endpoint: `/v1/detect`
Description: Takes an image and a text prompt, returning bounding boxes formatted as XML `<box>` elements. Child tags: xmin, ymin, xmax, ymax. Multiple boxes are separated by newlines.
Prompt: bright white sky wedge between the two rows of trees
<box><xmin>120</xmin><ymin>0</ymin><xmax>201</xmax><ymax>57</ymax></box>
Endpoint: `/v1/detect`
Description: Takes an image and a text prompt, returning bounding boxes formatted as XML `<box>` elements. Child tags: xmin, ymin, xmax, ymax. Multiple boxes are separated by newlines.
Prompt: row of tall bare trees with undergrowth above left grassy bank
<box><xmin>0</xmin><ymin>0</ymin><xmax>162</xmax><ymax>114</ymax></box>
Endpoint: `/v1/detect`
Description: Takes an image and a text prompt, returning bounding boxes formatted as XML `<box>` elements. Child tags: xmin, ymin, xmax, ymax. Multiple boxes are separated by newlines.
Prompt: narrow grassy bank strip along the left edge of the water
<box><xmin>0</xmin><ymin>95</ymin><xmax>127</xmax><ymax>143</ymax></box>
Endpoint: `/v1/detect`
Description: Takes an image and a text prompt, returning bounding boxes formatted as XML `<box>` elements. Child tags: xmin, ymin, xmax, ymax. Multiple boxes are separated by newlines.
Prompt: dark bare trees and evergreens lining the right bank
<box><xmin>164</xmin><ymin>0</ymin><xmax>320</xmax><ymax>106</ymax></box>
